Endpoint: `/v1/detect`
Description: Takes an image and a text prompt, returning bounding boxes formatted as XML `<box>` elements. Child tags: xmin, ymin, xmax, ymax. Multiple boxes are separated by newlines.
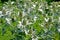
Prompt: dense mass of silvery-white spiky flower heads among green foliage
<box><xmin>0</xmin><ymin>0</ymin><xmax>60</xmax><ymax>40</ymax></box>
